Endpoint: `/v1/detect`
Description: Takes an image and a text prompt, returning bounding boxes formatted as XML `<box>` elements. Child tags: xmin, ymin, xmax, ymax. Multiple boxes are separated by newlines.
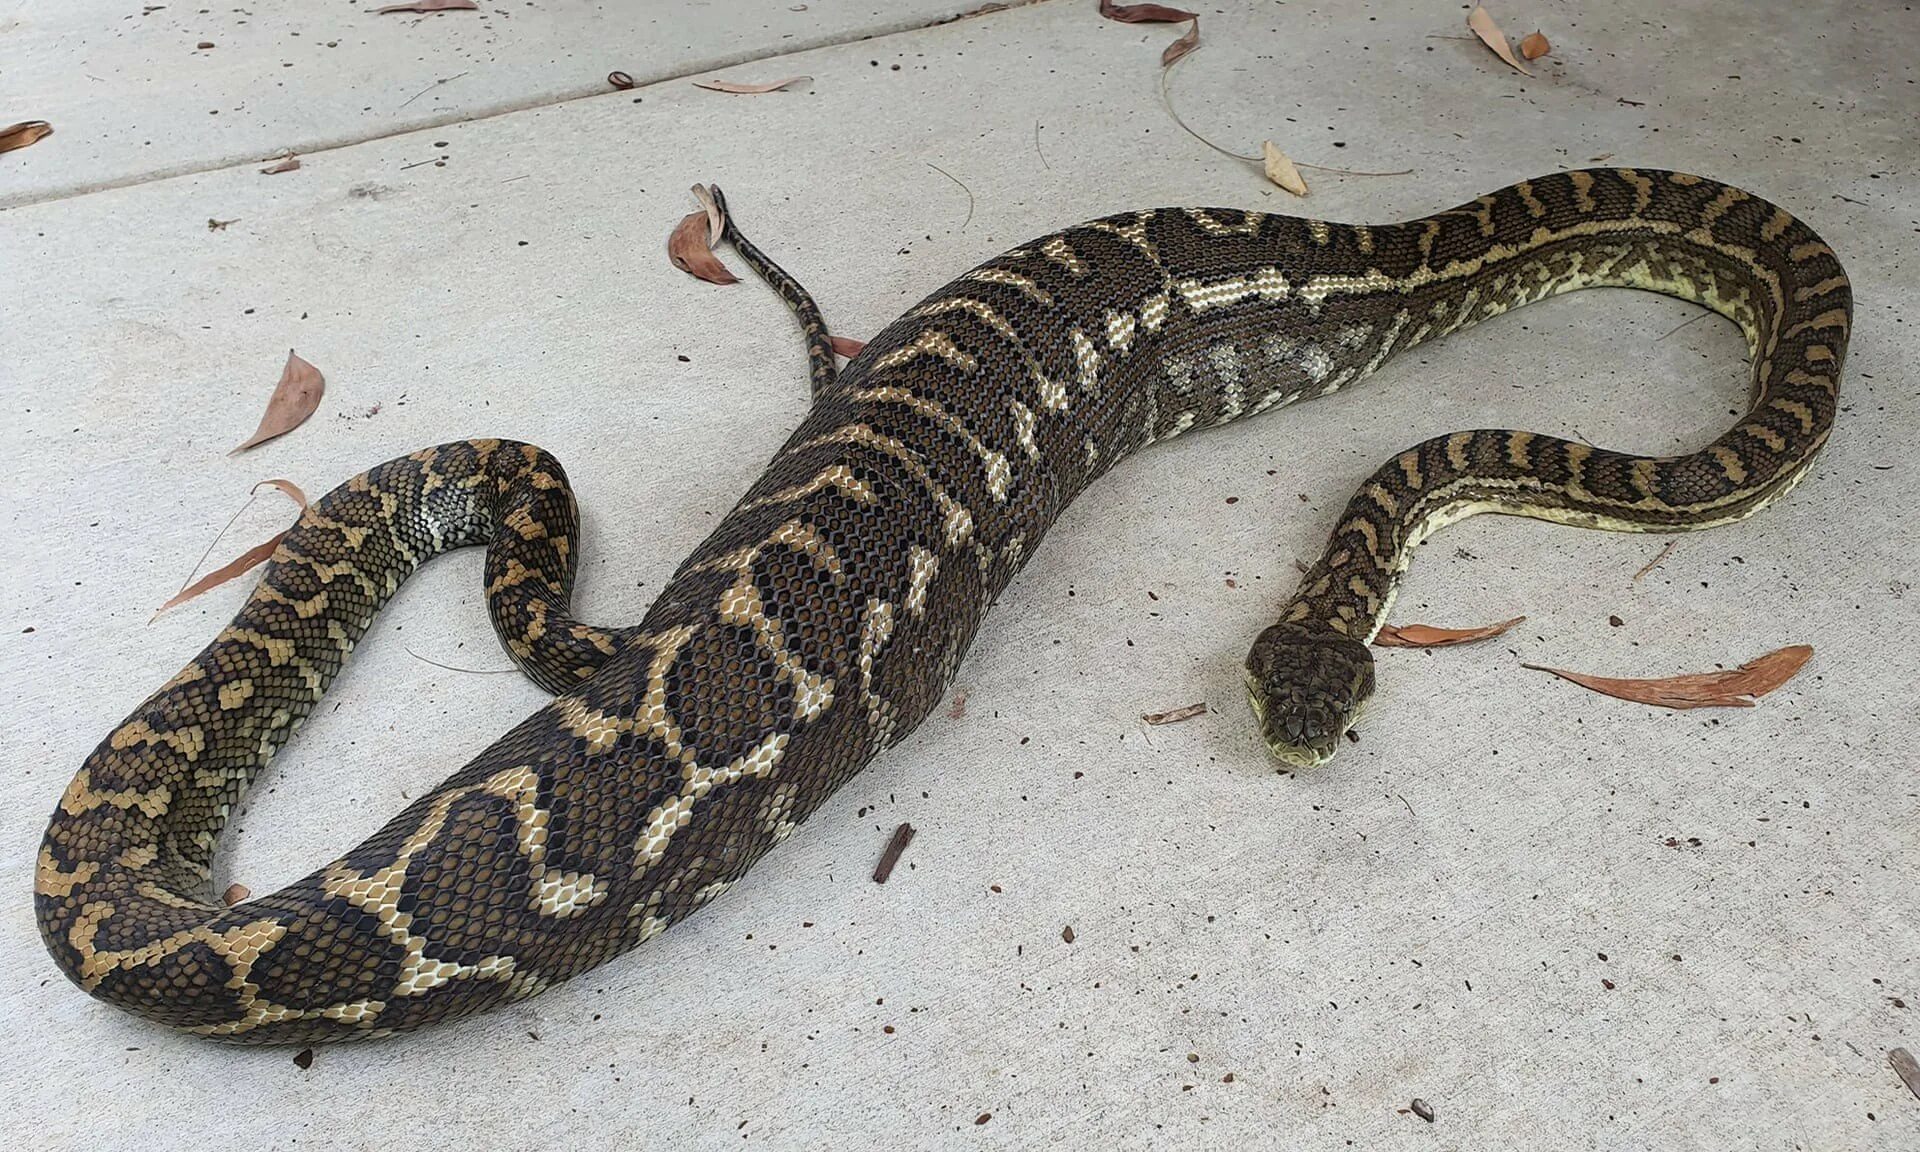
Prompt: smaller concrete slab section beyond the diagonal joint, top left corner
<box><xmin>0</xmin><ymin>0</ymin><xmax>972</xmax><ymax>207</ymax></box>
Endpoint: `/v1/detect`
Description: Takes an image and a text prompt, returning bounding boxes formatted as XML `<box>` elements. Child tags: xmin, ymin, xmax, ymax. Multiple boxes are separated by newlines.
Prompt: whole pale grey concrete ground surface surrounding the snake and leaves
<box><xmin>0</xmin><ymin>0</ymin><xmax>1920</xmax><ymax>1150</ymax></box>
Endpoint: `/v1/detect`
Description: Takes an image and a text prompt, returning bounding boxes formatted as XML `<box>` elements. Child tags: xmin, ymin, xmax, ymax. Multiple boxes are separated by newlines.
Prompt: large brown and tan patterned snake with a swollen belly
<box><xmin>35</xmin><ymin>169</ymin><xmax>1853</xmax><ymax>1044</ymax></box>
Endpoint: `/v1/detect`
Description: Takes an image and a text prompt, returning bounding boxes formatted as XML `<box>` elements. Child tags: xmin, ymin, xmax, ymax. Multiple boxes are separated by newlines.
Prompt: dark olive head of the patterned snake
<box><xmin>1246</xmin><ymin>624</ymin><xmax>1373</xmax><ymax>768</ymax></box>
